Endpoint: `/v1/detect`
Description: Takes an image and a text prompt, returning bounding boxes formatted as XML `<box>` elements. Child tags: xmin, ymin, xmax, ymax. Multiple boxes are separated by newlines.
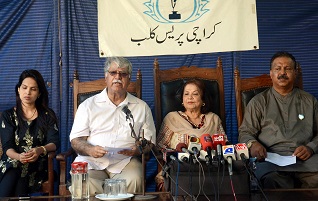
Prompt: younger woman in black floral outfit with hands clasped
<box><xmin>0</xmin><ymin>70</ymin><xmax>60</xmax><ymax>197</ymax></box>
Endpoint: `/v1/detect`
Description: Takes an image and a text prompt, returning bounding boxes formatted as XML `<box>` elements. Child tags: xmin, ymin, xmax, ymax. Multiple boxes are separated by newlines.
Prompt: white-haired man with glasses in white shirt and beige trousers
<box><xmin>70</xmin><ymin>57</ymin><xmax>156</xmax><ymax>195</ymax></box>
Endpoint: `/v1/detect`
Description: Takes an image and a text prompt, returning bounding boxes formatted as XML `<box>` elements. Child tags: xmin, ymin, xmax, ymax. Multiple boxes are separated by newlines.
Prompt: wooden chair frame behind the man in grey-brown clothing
<box><xmin>234</xmin><ymin>64</ymin><xmax>303</xmax><ymax>127</ymax></box>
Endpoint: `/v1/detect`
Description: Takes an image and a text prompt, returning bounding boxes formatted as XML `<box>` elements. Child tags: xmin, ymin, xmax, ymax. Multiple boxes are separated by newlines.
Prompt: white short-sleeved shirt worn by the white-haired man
<box><xmin>70</xmin><ymin>89</ymin><xmax>156</xmax><ymax>173</ymax></box>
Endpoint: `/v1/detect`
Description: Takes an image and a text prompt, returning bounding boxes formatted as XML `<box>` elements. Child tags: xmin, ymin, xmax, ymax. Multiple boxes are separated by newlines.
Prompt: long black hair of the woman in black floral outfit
<box><xmin>15</xmin><ymin>69</ymin><xmax>57</xmax><ymax>133</ymax></box>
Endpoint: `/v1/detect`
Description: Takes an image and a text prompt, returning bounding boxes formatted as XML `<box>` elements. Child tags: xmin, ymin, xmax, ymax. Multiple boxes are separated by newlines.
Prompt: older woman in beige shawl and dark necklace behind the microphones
<box><xmin>156</xmin><ymin>79</ymin><xmax>226</xmax><ymax>189</ymax></box>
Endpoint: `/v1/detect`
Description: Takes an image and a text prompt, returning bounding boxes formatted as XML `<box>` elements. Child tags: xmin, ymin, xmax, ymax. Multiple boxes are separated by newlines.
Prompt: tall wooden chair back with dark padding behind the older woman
<box><xmin>153</xmin><ymin>57</ymin><xmax>225</xmax><ymax>131</ymax></box>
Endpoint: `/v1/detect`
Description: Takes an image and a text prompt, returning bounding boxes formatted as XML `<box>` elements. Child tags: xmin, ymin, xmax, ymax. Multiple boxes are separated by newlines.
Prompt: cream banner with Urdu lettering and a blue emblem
<box><xmin>98</xmin><ymin>0</ymin><xmax>259</xmax><ymax>57</ymax></box>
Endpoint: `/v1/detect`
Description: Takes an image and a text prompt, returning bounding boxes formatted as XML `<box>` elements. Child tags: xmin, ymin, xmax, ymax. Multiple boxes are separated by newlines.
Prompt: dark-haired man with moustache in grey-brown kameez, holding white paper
<box><xmin>239</xmin><ymin>52</ymin><xmax>318</xmax><ymax>188</ymax></box>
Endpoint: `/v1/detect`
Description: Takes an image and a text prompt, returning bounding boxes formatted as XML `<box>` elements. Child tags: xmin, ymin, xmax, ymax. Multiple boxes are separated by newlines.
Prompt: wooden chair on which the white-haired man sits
<box><xmin>56</xmin><ymin>70</ymin><xmax>142</xmax><ymax>195</ymax></box>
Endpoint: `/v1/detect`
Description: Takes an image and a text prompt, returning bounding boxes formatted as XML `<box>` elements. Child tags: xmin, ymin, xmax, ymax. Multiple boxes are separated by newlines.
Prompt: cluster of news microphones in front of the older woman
<box><xmin>163</xmin><ymin>134</ymin><xmax>249</xmax><ymax>175</ymax></box>
